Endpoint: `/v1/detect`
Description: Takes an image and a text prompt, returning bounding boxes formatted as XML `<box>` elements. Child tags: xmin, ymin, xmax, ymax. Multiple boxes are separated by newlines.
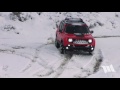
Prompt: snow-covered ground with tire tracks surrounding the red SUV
<box><xmin>0</xmin><ymin>12</ymin><xmax>120</xmax><ymax>78</ymax></box>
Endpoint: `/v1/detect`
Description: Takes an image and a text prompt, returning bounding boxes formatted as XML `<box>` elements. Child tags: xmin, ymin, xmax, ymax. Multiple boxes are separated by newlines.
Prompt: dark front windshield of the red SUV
<box><xmin>66</xmin><ymin>26</ymin><xmax>89</xmax><ymax>34</ymax></box>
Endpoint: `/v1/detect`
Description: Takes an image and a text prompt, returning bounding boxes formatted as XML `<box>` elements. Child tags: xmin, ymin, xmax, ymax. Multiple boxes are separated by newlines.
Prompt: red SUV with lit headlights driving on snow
<box><xmin>55</xmin><ymin>18</ymin><xmax>95</xmax><ymax>54</ymax></box>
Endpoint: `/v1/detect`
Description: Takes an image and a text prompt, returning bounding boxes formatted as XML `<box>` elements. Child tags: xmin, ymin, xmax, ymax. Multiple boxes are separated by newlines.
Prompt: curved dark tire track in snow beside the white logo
<box><xmin>74</xmin><ymin>50</ymin><xmax>103</xmax><ymax>78</ymax></box>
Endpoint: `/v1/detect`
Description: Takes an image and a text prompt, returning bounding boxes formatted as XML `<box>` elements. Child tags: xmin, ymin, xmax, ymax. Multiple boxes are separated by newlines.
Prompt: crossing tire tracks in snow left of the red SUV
<box><xmin>0</xmin><ymin>43</ymin><xmax>54</xmax><ymax>76</ymax></box>
